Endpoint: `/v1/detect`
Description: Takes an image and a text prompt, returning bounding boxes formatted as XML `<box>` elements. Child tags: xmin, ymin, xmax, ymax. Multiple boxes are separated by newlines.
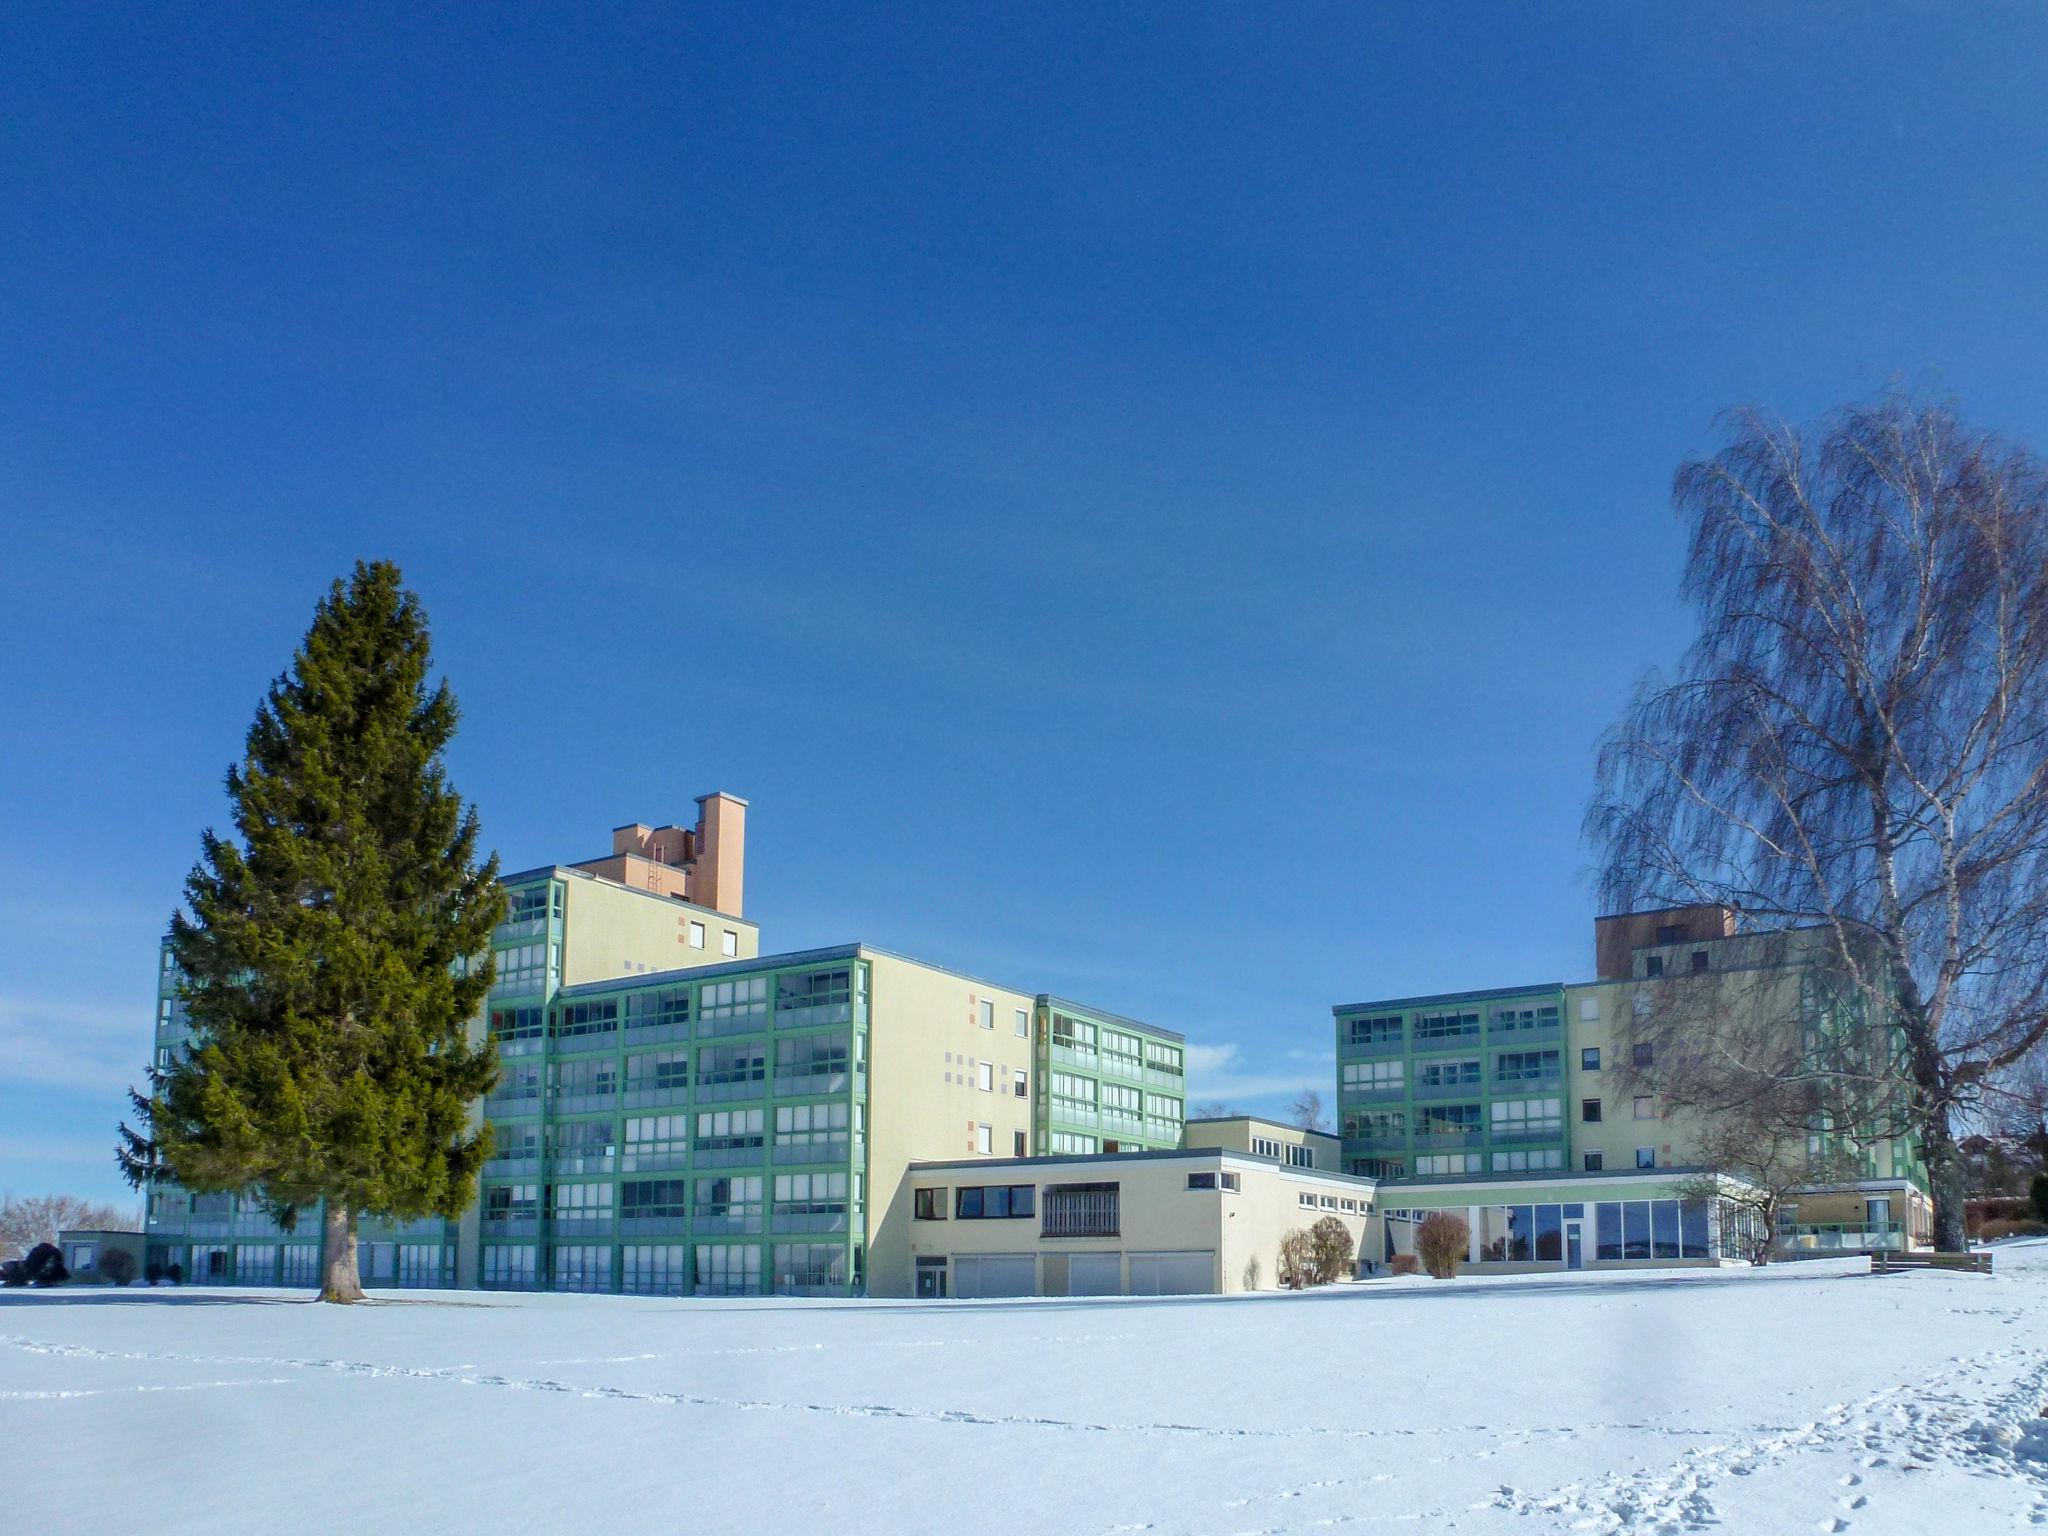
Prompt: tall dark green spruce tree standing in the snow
<box><xmin>119</xmin><ymin>561</ymin><xmax>504</xmax><ymax>1303</ymax></box>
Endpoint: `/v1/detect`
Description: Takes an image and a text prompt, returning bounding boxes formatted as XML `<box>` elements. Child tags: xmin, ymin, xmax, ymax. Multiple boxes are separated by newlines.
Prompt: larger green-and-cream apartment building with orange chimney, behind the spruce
<box><xmin>147</xmin><ymin>795</ymin><xmax>1186</xmax><ymax>1294</ymax></box>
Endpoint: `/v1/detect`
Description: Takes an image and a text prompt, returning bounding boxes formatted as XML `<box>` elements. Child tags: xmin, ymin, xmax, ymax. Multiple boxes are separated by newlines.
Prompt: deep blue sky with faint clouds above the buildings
<box><xmin>0</xmin><ymin>4</ymin><xmax>2048</xmax><ymax>1196</ymax></box>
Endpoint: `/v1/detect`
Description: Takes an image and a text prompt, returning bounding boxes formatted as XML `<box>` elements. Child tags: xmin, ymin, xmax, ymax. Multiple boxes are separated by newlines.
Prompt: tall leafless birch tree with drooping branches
<box><xmin>1587</xmin><ymin>395</ymin><xmax>2048</xmax><ymax>1251</ymax></box>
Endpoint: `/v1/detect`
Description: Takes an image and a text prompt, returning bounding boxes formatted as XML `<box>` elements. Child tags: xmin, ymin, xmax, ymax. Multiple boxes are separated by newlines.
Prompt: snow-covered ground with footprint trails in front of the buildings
<box><xmin>0</xmin><ymin>1243</ymin><xmax>2048</xmax><ymax>1536</ymax></box>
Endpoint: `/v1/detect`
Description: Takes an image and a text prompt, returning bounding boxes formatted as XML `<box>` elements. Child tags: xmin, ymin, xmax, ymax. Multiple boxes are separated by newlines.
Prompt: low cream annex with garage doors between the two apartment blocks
<box><xmin>901</xmin><ymin>1147</ymin><xmax>1376</xmax><ymax>1296</ymax></box>
